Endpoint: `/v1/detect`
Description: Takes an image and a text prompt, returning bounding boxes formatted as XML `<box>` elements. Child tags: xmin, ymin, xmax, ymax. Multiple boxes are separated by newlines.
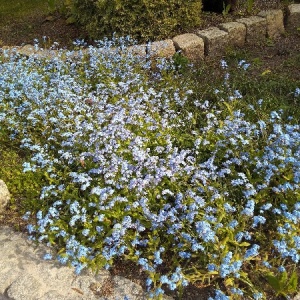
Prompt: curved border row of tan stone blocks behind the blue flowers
<box><xmin>0</xmin><ymin>4</ymin><xmax>300</xmax><ymax>62</ymax></box>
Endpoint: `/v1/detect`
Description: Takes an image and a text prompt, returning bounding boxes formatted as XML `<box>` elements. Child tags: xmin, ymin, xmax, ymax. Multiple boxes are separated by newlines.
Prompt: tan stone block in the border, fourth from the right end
<box><xmin>218</xmin><ymin>22</ymin><xmax>246</xmax><ymax>47</ymax></box>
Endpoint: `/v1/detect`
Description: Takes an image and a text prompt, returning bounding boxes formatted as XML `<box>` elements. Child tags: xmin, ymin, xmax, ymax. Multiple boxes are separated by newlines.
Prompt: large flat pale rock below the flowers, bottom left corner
<box><xmin>0</xmin><ymin>226</ymin><xmax>172</xmax><ymax>300</ymax></box>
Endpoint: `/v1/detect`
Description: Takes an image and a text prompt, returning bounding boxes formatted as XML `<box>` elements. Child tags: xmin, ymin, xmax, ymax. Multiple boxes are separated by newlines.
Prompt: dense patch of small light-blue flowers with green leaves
<box><xmin>0</xmin><ymin>39</ymin><xmax>300</xmax><ymax>299</ymax></box>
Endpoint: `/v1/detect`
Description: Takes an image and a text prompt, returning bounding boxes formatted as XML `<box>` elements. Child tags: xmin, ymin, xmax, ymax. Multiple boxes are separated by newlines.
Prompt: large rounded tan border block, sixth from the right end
<box><xmin>173</xmin><ymin>33</ymin><xmax>204</xmax><ymax>62</ymax></box>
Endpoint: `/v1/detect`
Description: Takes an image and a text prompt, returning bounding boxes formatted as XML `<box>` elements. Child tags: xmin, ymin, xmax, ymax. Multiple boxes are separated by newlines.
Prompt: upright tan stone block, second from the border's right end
<box><xmin>258</xmin><ymin>9</ymin><xmax>285</xmax><ymax>38</ymax></box>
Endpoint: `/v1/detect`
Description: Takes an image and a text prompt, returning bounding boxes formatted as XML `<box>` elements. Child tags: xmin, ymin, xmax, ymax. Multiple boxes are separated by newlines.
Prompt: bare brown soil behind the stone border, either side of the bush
<box><xmin>0</xmin><ymin>0</ymin><xmax>291</xmax><ymax>47</ymax></box>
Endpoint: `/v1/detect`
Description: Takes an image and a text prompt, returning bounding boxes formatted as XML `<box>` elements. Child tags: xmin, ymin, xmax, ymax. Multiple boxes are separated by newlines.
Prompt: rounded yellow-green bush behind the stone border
<box><xmin>65</xmin><ymin>0</ymin><xmax>202</xmax><ymax>41</ymax></box>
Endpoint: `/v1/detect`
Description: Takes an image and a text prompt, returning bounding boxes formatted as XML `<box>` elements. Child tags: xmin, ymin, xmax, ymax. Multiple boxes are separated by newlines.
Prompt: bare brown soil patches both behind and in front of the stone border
<box><xmin>0</xmin><ymin>0</ymin><xmax>300</xmax><ymax>76</ymax></box>
